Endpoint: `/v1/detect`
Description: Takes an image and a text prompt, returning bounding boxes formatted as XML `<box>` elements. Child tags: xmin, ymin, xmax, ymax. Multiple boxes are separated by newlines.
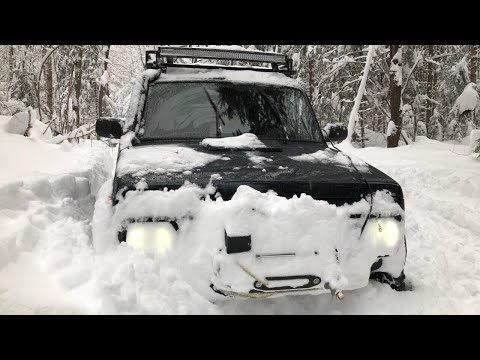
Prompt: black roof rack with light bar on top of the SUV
<box><xmin>145</xmin><ymin>46</ymin><xmax>294</xmax><ymax>76</ymax></box>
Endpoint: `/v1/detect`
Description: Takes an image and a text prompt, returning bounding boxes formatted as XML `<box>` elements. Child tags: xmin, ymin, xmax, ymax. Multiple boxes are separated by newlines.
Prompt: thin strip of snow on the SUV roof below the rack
<box><xmin>153</xmin><ymin>68</ymin><xmax>303</xmax><ymax>89</ymax></box>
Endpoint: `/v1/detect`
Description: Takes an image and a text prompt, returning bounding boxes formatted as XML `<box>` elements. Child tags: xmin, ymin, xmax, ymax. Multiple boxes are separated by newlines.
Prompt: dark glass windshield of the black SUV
<box><xmin>142</xmin><ymin>82</ymin><xmax>324</xmax><ymax>142</ymax></box>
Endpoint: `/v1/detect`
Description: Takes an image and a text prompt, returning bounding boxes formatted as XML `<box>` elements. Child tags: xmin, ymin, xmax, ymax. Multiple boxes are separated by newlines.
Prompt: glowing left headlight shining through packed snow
<box><xmin>126</xmin><ymin>222</ymin><xmax>176</xmax><ymax>256</ymax></box>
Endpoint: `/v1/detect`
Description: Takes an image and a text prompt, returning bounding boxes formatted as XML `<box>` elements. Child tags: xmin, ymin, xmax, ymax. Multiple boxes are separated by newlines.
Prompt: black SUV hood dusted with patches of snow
<box><xmin>114</xmin><ymin>141</ymin><xmax>403</xmax><ymax>208</ymax></box>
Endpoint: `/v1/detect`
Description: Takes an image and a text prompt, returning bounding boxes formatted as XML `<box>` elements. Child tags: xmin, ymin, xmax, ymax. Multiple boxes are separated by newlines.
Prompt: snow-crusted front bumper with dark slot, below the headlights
<box><xmin>210</xmin><ymin>233</ymin><xmax>406</xmax><ymax>299</ymax></box>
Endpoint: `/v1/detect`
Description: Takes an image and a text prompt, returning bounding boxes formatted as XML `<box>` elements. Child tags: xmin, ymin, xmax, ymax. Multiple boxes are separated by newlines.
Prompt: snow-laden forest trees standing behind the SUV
<box><xmin>0</xmin><ymin>45</ymin><xmax>480</xmax><ymax>147</ymax></box>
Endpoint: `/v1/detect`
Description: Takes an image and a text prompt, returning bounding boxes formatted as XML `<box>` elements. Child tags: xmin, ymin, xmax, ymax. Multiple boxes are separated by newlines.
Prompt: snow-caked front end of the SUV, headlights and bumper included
<box><xmin>109</xmin><ymin>184</ymin><xmax>406</xmax><ymax>298</ymax></box>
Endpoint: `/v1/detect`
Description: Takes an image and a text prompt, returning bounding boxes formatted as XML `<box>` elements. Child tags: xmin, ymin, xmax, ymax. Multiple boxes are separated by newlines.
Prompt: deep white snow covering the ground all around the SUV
<box><xmin>0</xmin><ymin>119</ymin><xmax>480</xmax><ymax>314</ymax></box>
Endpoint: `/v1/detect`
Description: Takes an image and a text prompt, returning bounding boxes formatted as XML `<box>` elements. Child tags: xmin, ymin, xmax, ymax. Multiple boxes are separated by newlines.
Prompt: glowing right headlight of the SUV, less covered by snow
<box><xmin>364</xmin><ymin>218</ymin><xmax>403</xmax><ymax>249</ymax></box>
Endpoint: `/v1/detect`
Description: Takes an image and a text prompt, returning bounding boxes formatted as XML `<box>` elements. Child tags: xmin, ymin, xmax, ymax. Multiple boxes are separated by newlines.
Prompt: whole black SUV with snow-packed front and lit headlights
<box><xmin>96</xmin><ymin>48</ymin><xmax>407</xmax><ymax>298</ymax></box>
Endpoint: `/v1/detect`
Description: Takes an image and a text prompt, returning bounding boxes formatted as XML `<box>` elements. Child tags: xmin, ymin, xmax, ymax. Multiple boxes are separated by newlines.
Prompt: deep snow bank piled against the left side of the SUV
<box><xmin>0</xmin><ymin>128</ymin><xmax>218</xmax><ymax>314</ymax></box>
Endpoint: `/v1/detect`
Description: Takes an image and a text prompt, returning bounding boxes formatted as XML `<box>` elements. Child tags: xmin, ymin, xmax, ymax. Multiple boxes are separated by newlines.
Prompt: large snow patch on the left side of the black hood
<box><xmin>117</xmin><ymin>144</ymin><xmax>222</xmax><ymax>177</ymax></box>
